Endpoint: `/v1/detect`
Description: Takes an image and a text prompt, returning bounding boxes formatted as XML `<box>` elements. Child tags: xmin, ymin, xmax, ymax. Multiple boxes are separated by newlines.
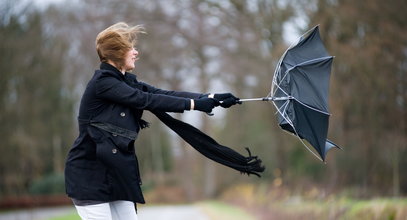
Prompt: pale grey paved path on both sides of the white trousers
<box><xmin>0</xmin><ymin>205</ymin><xmax>209</xmax><ymax>220</ymax></box>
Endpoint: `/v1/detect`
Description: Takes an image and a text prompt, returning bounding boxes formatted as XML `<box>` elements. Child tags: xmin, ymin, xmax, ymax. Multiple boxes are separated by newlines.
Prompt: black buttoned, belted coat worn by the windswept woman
<box><xmin>65</xmin><ymin>63</ymin><xmax>203</xmax><ymax>203</ymax></box>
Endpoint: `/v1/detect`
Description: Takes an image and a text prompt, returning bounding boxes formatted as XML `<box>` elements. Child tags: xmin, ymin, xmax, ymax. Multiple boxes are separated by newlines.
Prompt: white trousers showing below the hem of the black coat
<box><xmin>75</xmin><ymin>201</ymin><xmax>137</xmax><ymax>220</ymax></box>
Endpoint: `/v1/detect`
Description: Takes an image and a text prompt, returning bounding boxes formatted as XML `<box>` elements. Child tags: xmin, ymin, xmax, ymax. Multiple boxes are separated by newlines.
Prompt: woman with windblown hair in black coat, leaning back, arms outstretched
<box><xmin>65</xmin><ymin>22</ymin><xmax>238</xmax><ymax>220</ymax></box>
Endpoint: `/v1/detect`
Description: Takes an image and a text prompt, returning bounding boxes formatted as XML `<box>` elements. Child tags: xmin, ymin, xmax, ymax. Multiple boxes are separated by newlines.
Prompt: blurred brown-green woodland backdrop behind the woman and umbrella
<box><xmin>0</xmin><ymin>0</ymin><xmax>407</xmax><ymax>206</ymax></box>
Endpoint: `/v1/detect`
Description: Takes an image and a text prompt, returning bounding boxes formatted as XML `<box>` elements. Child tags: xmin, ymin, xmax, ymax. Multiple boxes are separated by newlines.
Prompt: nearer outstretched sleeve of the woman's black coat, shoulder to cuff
<box><xmin>95</xmin><ymin>75</ymin><xmax>190</xmax><ymax>112</ymax></box>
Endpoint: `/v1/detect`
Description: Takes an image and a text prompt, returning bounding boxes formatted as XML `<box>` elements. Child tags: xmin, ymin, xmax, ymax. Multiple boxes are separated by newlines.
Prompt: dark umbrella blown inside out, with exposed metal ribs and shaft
<box><xmin>240</xmin><ymin>26</ymin><xmax>339</xmax><ymax>161</ymax></box>
